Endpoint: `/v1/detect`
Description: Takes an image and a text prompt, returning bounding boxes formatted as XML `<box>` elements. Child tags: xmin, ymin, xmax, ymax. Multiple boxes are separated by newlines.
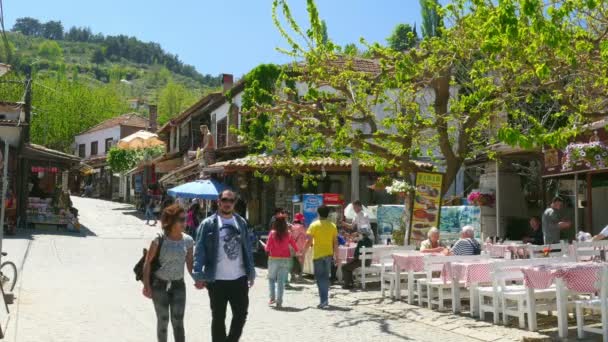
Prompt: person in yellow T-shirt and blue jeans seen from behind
<box><xmin>304</xmin><ymin>206</ymin><xmax>338</xmax><ymax>309</ymax></box>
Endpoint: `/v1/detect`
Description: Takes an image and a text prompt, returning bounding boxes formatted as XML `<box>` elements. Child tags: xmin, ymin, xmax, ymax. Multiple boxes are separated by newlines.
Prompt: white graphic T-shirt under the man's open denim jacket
<box><xmin>215</xmin><ymin>216</ymin><xmax>246</xmax><ymax>280</ymax></box>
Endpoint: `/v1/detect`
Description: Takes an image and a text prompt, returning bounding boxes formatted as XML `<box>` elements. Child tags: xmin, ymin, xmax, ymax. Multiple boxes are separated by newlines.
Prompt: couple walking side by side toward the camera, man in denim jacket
<box><xmin>143</xmin><ymin>190</ymin><xmax>255</xmax><ymax>342</ymax></box>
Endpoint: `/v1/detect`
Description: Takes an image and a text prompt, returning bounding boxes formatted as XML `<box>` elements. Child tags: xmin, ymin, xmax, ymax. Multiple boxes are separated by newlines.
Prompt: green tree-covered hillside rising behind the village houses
<box><xmin>0</xmin><ymin>18</ymin><xmax>220</xmax><ymax>153</ymax></box>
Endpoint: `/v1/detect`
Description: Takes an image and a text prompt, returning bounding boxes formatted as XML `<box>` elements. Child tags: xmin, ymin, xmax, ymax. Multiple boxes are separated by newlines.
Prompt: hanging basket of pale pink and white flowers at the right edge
<box><xmin>562</xmin><ymin>141</ymin><xmax>608</xmax><ymax>171</ymax></box>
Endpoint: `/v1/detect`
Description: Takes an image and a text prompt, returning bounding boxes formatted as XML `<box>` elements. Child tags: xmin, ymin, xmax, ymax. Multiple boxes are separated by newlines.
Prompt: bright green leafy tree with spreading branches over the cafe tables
<box><xmin>244</xmin><ymin>0</ymin><xmax>608</xmax><ymax>195</ymax></box>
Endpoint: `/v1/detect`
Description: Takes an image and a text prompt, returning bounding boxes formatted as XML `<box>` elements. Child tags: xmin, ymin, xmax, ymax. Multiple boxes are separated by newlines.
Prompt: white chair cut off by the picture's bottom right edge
<box><xmin>575</xmin><ymin>265</ymin><xmax>608</xmax><ymax>342</ymax></box>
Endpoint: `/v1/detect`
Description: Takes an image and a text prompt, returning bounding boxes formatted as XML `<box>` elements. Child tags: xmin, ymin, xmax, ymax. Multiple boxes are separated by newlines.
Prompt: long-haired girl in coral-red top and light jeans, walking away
<box><xmin>266</xmin><ymin>217</ymin><xmax>300</xmax><ymax>308</ymax></box>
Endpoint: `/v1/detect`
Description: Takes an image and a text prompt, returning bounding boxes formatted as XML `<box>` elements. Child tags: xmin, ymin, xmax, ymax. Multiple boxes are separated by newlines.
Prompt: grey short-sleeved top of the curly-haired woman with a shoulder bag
<box><xmin>154</xmin><ymin>233</ymin><xmax>194</xmax><ymax>281</ymax></box>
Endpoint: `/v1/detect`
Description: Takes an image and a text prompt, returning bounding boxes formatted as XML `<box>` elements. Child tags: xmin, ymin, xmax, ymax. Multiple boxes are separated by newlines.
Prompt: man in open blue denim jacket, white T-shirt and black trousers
<box><xmin>192</xmin><ymin>190</ymin><xmax>255</xmax><ymax>342</ymax></box>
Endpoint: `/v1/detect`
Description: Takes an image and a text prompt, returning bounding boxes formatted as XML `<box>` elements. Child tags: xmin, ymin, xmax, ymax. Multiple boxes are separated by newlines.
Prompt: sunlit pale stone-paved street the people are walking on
<box><xmin>0</xmin><ymin>197</ymin><xmax>575</xmax><ymax>342</ymax></box>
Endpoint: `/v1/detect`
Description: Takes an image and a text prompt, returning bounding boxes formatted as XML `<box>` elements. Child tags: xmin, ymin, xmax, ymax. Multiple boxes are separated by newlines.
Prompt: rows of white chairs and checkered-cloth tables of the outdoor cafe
<box><xmin>350</xmin><ymin>241</ymin><xmax>608</xmax><ymax>341</ymax></box>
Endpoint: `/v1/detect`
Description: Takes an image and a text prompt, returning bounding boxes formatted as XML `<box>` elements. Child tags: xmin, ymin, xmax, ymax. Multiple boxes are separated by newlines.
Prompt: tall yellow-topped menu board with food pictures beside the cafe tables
<box><xmin>410</xmin><ymin>172</ymin><xmax>443</xmax><ymax>243</ymax></box>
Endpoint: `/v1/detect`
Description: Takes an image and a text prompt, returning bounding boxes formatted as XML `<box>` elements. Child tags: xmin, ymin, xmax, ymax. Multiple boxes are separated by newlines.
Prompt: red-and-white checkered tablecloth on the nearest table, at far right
<box><xmin>522</xmin><ymin>263</ymin><xmax>602</xmax><ymax>292</ymax></box>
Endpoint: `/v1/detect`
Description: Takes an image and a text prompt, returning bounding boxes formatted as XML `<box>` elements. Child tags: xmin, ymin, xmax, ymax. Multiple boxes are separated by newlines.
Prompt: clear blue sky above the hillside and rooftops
<box><xmin>4</xmin><ymin>0</ymin><xmax>421</xmax><ymax>77</ymax></box>
